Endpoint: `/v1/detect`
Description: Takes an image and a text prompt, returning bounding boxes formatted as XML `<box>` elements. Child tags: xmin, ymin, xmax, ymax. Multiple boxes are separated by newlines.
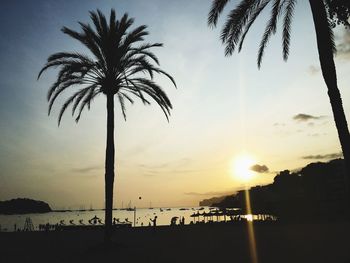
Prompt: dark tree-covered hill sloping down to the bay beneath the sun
<box><xmin>202</xmin><ymin>159</ymin><xmax>347</xmax><ymax>220</ymax></box>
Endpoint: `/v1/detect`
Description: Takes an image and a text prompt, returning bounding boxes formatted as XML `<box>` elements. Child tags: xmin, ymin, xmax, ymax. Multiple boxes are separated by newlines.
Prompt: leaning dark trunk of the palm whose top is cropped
<box><xmin>309</xmin><ymin>0</ymin><xmax>350</xmax><ymax>196</ymax></box>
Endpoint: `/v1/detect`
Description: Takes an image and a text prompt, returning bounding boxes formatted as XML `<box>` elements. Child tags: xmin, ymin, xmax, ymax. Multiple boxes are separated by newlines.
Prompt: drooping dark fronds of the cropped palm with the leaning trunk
<box><xmin>208</xmin><ymin>0</ymin><xmax>336</xmax><ymax>68</ymax></box>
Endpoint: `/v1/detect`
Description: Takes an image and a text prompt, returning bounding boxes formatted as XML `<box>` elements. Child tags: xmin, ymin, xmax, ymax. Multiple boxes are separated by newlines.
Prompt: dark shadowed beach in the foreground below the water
<box><xmin>0</xmin><ymin>222</ymin><xmax>350</xmax><ymax>263</ymax></box>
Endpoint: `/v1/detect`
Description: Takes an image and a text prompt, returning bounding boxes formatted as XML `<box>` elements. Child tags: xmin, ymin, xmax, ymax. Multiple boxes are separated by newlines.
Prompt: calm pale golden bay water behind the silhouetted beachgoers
<box><xmin>0</xmin><ymin>207</ymin><xmax>215</xmax><ymax>231</ymax></box>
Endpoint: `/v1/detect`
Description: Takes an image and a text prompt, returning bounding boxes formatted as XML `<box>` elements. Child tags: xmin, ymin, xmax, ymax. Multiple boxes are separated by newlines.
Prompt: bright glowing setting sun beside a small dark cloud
<box><xmin>232</xmin><ymin>154</ymin><xmax>255</xmax><ymax>182</ymax></box>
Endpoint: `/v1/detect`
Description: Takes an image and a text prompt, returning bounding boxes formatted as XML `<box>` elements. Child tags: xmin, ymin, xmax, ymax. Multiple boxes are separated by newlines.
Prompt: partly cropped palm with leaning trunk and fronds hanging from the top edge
<box><xmin>208</xmin><ymin>0</ymin><xmax>350</xmax><ymax>187</ymax></box>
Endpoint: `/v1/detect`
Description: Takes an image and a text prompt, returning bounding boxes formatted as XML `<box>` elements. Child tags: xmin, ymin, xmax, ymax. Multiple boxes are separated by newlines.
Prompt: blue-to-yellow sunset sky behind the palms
<box><xmin>0</xmin><ymin>0</ymin><xmax>350</xmax><ymax>209</ymax></box>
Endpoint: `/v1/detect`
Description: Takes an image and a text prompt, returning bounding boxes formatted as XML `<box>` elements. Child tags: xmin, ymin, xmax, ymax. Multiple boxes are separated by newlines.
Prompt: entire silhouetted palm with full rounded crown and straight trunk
<box><xmin>38</xmin><ymin>9</ymin><xmax>176</xmax><ymax>242</ymax></box>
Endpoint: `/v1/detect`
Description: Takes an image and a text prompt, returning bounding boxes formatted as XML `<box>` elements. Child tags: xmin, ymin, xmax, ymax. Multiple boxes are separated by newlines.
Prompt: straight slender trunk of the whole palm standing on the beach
<box><xmin>105</xmin><ymin>94</ymin><xmax>115</xmax><ymax>243</ymax></box>
